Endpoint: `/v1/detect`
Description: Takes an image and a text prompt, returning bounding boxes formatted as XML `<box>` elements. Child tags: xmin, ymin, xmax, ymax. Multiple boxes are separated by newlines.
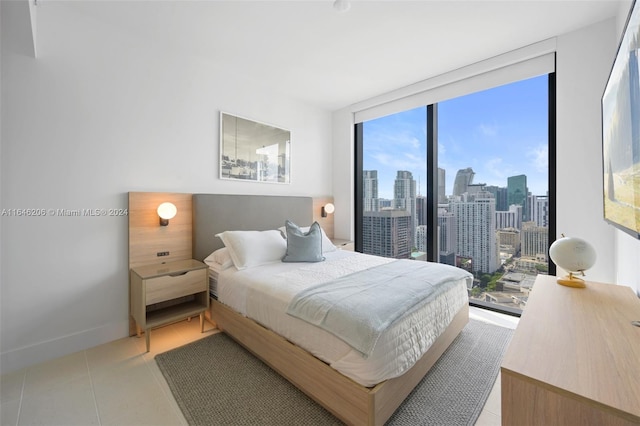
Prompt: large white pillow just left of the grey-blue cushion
<box><xmin>216</xmin><ymin>230</ymin><xmax>287</xmax><ymax>269</ymax></box>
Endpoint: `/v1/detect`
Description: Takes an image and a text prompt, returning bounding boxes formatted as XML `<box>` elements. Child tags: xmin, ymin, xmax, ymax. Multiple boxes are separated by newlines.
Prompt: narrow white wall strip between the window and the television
<box><xmin>556</xmin><ymin>19</ymin><xmax>616</xmax><ymax>282</ymax></box>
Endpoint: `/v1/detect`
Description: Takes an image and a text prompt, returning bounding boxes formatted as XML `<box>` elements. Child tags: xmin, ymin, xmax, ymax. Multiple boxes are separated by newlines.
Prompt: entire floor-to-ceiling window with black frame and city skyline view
<box><xmin>356</xmin><ymin>74</ymin><xmax>555</xmax><ymax>314</ymax></box>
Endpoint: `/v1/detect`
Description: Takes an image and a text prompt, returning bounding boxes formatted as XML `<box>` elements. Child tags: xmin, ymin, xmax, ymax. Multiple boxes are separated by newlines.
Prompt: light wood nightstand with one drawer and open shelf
<box><xmin>130</xmin><ymin>259</ymin><xmax>209</xmax><ymax>352</ymax></box>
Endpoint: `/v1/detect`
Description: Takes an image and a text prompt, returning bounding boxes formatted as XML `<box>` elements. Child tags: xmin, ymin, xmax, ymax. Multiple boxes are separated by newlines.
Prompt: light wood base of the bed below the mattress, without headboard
<box><xmin>211</xmin><ymin>299</ymin><xmax>469</xmax><ymax>426</ymax></box>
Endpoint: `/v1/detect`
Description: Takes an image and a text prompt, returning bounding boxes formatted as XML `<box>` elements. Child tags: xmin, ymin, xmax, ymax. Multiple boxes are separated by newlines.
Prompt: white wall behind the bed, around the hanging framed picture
<box><xmin>0</xmin><ymin>2</ymin><xmax>332</xmax><ymax>373</ymax></box>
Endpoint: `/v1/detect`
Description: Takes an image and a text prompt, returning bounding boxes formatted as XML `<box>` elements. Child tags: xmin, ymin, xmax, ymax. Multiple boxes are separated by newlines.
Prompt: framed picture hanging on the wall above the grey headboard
<box><xmin>220</xmin><ymin>111</ymin><xmax>291</xmax><ymax>184</ymax></box>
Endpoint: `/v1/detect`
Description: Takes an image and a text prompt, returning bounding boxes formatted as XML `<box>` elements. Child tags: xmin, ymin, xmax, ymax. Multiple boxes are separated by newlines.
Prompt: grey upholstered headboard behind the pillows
<box><xmin>192</xmin><ymin>194</ymin><xmax>322</xmax><ymax>260</ymax></box>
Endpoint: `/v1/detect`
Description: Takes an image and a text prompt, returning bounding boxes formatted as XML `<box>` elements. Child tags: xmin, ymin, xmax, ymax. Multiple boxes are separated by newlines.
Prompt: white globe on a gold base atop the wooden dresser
<box><xmin>549</xmin><ymin>234</ymin><xmax>596</xmax><ymax>288</ymax></box>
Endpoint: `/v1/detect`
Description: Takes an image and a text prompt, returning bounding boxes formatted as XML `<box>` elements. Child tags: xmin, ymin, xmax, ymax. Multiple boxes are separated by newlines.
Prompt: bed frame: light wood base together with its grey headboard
<box><xmin>193</xmin><ymin>194</ymin><xmax>469</xmax><ymax>425</ymax></box>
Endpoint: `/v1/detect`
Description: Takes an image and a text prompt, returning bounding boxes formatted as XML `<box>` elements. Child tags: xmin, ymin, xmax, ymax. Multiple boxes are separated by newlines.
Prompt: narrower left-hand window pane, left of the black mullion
<box><xmin>362</xmin><ymin>106</ymin><xmax>427</xmax><ymax>260</ymax></box>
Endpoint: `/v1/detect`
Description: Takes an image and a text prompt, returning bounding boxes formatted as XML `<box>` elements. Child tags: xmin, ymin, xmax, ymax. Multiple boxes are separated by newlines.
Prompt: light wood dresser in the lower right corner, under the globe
<box><xmin>501</xmin><ymin>275</ymin><xmax>640</xmax><ymax>426</ymax></box>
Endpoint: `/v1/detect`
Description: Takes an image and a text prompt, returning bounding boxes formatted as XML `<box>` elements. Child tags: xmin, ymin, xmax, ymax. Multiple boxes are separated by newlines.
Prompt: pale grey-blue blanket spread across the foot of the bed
<box><xmin>287</xmin><ymin>260</ymin><xmax>473</xmax><ymax>358</ymax></box>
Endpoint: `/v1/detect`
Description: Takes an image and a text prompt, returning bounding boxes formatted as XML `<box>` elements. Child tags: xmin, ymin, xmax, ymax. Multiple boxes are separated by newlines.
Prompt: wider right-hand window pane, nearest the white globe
<box><xmin>438</xmin><ymin>76</ymin><xmax>549</xmax><ymax>311</ymax></box>
